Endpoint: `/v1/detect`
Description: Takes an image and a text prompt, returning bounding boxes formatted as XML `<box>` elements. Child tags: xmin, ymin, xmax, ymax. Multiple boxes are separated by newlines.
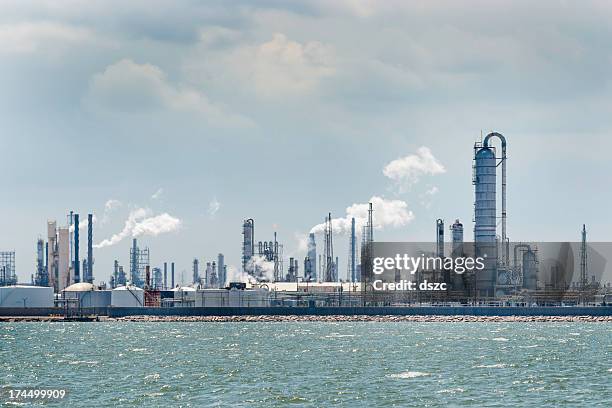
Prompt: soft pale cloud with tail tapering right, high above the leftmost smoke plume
<box><xmin>86</xmin><ymin>59</ymin><xmax>254</xmax><ymax>127</ymax></box>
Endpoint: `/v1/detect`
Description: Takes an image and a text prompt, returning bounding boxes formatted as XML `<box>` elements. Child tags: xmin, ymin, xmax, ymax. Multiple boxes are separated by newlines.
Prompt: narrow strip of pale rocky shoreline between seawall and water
<box><xmin>0</xmin><ymin>315</ymin><xmax>612</xmax><ymax>323</ymax></box>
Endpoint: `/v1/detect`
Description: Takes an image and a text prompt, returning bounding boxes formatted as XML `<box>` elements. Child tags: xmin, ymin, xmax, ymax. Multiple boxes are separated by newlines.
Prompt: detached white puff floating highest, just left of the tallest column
<box><xmin>383</xmin><ymin>146</ymin><xmax>446</xmax><ymax>191</ymax></box>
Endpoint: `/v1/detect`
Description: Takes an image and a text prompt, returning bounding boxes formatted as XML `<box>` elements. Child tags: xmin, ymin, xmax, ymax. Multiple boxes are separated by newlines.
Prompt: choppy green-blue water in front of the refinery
<box><xmin>0</xmin><ymin>322</ymin><xmax>612</xmax><ymax>407</ymax></box>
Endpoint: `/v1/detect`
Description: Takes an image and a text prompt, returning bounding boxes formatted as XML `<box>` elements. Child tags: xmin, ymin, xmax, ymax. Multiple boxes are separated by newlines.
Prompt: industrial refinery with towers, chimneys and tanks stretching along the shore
<box><xmin>0</xmin><ymin>132</ymin><xmax>611</xmax><ymax>313</ymax></box>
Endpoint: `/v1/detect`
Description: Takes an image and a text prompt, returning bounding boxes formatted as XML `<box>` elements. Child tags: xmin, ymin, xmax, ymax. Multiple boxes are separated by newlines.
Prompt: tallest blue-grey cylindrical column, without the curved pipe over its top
<box><xmin>474</xmin><ymin>147</ymin><xmax>497</xmax><ymax>296</ymax></box>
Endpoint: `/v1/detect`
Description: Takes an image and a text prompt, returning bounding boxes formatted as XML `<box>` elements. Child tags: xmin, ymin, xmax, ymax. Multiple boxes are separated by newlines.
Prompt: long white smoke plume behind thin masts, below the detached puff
<box><xmin>310</xmin><ymin>196</ymin><xmax>414</xmax><ymax>235</ymax></box>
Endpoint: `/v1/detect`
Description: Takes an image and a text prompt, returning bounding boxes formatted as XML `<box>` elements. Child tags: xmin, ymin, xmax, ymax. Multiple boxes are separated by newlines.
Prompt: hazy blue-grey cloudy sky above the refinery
<box><xmin>0</xmin><ymin>0</ymin><xmax>612</xmax><ymax>282</ymax></box>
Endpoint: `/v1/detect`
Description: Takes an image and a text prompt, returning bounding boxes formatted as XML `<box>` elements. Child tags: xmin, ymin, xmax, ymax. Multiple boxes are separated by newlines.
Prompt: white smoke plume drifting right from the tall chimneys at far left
<box><xmin>94</xmin><ymin>208</ymin><xmax>181</xmax><ymax>248</ymax></box>
